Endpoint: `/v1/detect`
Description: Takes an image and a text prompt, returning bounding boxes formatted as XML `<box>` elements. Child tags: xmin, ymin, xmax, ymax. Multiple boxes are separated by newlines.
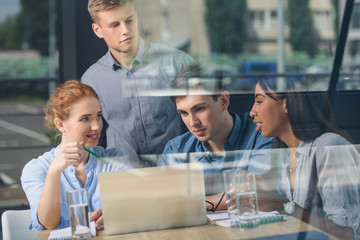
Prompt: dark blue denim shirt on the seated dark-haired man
<box><xmin>157</xmin><ymin>112</ymin><xmax>274</xmax><ymax>195</ymax></box>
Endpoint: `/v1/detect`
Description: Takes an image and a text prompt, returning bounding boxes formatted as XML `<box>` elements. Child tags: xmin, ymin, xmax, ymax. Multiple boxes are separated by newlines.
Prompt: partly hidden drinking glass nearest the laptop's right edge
<box><xmin>223</xmin><ymin>169</ymin><xmax>239</xmax><ymax>227</ymax></box>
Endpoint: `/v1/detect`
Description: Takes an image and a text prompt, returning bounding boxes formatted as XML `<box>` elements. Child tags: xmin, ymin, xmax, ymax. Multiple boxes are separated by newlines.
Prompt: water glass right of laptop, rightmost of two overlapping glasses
<box><xmin>234</xmin><ymin>172</ymin><xmax>260</xmax><ymax>229</ymax></box>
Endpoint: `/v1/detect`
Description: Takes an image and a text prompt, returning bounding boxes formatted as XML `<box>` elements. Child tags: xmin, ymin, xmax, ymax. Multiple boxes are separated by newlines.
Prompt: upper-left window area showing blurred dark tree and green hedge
<box><xmin>0</xmin><ymin>0</ymin><xmax>58</xmax><ymax>78</ymax></box>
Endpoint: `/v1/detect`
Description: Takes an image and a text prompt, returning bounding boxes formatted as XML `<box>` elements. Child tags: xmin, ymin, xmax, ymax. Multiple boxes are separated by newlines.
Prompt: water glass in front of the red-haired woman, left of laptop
<box><xmin>67</xmin><ymin>189</ymin><xmax>91</xmax><ymax>239</ymax></box>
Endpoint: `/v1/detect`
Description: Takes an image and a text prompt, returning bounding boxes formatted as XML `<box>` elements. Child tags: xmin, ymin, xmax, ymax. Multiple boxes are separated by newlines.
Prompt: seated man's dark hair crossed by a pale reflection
<box><xmin>170</xmin><ymin>63</ymin><xmax>222</xmax><ymax>103</ymax></box>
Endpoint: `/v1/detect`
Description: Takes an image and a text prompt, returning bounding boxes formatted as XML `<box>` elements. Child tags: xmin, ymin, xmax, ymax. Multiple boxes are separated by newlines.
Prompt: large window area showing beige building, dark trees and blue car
<box><xmin>135</xmin><ymin>0</ymin><xmax>339</xmax><ymax>92</ymax></box>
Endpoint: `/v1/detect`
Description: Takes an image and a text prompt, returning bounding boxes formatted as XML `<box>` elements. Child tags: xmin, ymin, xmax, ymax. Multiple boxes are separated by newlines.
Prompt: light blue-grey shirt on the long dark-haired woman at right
<box><xmin>278</xmin><ymin>133</ymin><xmax>360</xmax><ymax>239</ymax></box>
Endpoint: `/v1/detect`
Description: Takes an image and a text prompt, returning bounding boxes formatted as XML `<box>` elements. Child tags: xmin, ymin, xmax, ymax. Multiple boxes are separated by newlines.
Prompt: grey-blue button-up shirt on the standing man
<box><xmin>81</xmin><ymin>38</ymin><xmax>193</xmax><ymax>166</ymax></box>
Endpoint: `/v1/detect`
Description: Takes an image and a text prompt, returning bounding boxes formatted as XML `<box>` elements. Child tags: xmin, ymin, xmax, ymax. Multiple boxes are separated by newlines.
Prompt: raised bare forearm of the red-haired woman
<box><xmin>37</xmin><ymin>169</ymin><xmax>61</xmax><ymax>229</ymax></box>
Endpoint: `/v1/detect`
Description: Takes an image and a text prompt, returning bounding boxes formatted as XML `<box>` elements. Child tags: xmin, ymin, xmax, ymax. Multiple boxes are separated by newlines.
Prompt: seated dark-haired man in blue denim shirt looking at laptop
<box><xmin>158</xmin><ymin>64</ymin><xmax>273</xmax><ymax>208</ymax></box>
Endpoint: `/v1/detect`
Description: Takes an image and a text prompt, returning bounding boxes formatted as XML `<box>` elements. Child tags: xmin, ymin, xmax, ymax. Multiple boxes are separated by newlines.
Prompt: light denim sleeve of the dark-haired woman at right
<box><xmin>317</xmin><ymin>142</ymin><xmax>360</xmax><ymax>239</ymax></box>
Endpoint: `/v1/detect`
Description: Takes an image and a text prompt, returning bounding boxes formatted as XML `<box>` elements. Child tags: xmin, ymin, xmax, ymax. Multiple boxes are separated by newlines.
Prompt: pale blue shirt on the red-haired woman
<box><xmin>21</xmin><ymin>146</ymin><xmax>131</xmax><ymax>230</ymax></box>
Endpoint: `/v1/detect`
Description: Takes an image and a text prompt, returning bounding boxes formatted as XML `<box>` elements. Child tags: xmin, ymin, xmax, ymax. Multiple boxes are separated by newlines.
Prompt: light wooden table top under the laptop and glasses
<box><xmin>37</xmin><ymin>216</ymin><xmax>337</xmax><ymax>240</ymax></box>
